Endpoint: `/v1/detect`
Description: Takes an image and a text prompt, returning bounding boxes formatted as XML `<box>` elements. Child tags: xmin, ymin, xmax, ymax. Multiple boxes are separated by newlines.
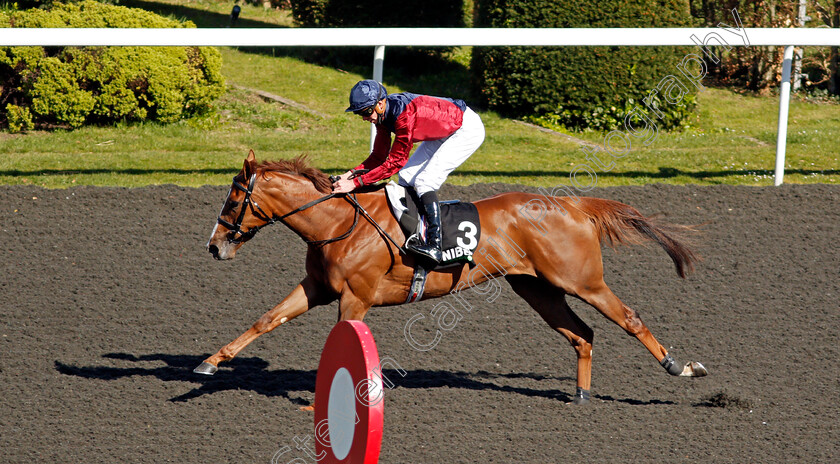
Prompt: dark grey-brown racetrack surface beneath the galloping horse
<box><xmin>0</xmin><ymin>185</ymin><xmax>840</xmax><ymax>463</ymax></box>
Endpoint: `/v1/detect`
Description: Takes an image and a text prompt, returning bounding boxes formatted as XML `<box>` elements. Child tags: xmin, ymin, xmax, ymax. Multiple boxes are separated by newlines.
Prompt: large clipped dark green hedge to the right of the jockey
<box><xmin>472</xmin><ymin>0</ymin><xmax>694</xmax><ymax>129</ymax></box>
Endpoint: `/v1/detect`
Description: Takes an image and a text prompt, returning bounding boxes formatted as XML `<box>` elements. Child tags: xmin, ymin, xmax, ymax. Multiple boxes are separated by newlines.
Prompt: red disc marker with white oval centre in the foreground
<box><xmin>315</xmin><ymin>321</ymin><xmax>385</xmax><ymax>464</ymax></box>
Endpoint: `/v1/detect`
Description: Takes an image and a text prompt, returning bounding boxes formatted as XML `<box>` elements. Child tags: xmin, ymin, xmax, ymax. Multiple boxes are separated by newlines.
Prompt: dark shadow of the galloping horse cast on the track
<box><xmin>55</xmin><ymin>353</ymin><xmax>667</xmax><ymax>405</ymax></box>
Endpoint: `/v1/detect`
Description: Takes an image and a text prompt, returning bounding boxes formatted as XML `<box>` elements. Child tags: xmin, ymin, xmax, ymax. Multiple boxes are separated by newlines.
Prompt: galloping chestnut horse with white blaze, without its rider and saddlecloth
<box><xmin>195</xmin><ymin>151</ymin><xmax>706</xmax><ymax>404</ymax></box>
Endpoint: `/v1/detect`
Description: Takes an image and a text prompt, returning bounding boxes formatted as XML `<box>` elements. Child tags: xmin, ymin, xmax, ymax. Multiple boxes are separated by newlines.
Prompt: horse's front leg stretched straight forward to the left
<box><xmin>193</xmin><ymin>276</ymin><xmax>335</xmax><ymax>375</ymax></box>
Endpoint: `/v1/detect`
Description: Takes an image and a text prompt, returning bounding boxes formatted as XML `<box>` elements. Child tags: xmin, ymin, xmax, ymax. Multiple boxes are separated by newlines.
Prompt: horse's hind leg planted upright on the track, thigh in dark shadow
<box><xmin>506</xmin><ymin>276</ymin><xmax>593</xmax><ymax>404</ymax></box>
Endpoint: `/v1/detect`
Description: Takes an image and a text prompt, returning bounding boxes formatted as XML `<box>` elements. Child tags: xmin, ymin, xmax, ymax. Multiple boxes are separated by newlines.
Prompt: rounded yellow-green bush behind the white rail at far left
<box><xmin>0</xmin><ymin>1</ymin><xmax>225</xmax><ymax>131</ymax></box>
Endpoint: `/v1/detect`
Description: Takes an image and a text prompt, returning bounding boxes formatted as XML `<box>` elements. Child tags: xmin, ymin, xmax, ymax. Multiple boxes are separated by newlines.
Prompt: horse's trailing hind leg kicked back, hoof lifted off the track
<box><xmin>577</xmin><ymin>279</ymin><xmax>708</xmax><ymax>377</ymax></box>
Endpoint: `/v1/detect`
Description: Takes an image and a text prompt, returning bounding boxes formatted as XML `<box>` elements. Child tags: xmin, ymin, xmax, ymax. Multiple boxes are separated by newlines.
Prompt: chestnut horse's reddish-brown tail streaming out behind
<box><xmin>575</xmin><ymin>198</ymin><xmax>698</xmax><ymax>278</ymax></box>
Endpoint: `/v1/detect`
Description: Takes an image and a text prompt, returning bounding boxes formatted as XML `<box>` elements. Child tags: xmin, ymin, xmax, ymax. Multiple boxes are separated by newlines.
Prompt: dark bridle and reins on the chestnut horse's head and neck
<box><xmin>216</xmin><ymin>173</ymin><xmax>405</xmax><ymax>253</ymax></box>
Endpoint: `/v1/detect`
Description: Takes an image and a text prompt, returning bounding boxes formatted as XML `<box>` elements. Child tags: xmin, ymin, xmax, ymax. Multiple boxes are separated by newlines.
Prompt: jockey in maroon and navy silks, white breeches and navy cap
<box><xmin>333</xmin><ymin>79</ymin><xmax>484</xmax><ymax>263</ymax></box>
